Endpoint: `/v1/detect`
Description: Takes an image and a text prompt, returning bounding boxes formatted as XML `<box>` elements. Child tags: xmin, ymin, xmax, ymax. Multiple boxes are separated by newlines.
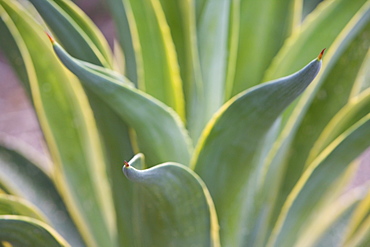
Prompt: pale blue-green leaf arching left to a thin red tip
<box><xmin>53</xmin><ymin>40</ymin><xmax>191</xmax><ymax>166</ymax></box>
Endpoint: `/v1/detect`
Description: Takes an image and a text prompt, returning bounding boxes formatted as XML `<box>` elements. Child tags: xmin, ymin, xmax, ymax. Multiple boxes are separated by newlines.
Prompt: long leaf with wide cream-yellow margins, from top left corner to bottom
<box><xmin>1</xmin><ymin>0</ymin><xmax>114</xmax><ymax>246</ymax></box>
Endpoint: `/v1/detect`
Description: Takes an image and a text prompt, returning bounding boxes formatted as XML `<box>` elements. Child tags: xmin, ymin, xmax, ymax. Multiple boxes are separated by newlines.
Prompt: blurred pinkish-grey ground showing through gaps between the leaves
<box><xmin>0</xmin><ymin>0</ymin><xmax>370</xmax><ymax>187</ymax></box>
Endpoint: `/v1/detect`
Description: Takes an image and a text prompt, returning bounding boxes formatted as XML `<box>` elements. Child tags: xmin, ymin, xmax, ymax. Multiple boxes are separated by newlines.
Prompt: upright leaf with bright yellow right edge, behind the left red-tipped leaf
<box><xmin>123</xmin><ymin>0</ymin><xmax>185</xmax><ymax>120</ymax></box>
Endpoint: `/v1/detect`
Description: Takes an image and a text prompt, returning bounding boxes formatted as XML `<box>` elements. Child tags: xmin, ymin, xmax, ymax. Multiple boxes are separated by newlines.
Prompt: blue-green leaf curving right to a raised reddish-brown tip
<box><xmin>192</xmin><ymin>54</ymin><xmax>322</xmax><ymax>246</ymax></box>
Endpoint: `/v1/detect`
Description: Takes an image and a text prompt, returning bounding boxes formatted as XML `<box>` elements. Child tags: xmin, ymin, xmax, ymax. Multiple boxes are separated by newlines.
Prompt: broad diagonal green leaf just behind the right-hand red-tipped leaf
<box><xmin>277</xmin><ymin>12</ymin><xmax>370</xmax><ymax>209</ymax></box>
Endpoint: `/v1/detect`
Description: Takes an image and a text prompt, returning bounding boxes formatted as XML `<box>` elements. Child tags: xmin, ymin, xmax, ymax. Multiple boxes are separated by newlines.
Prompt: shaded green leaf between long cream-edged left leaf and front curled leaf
<box><xmin>92</xmin><ymin>111</ymin><xmax>135</xmax><ymax>246</ymax></box>
